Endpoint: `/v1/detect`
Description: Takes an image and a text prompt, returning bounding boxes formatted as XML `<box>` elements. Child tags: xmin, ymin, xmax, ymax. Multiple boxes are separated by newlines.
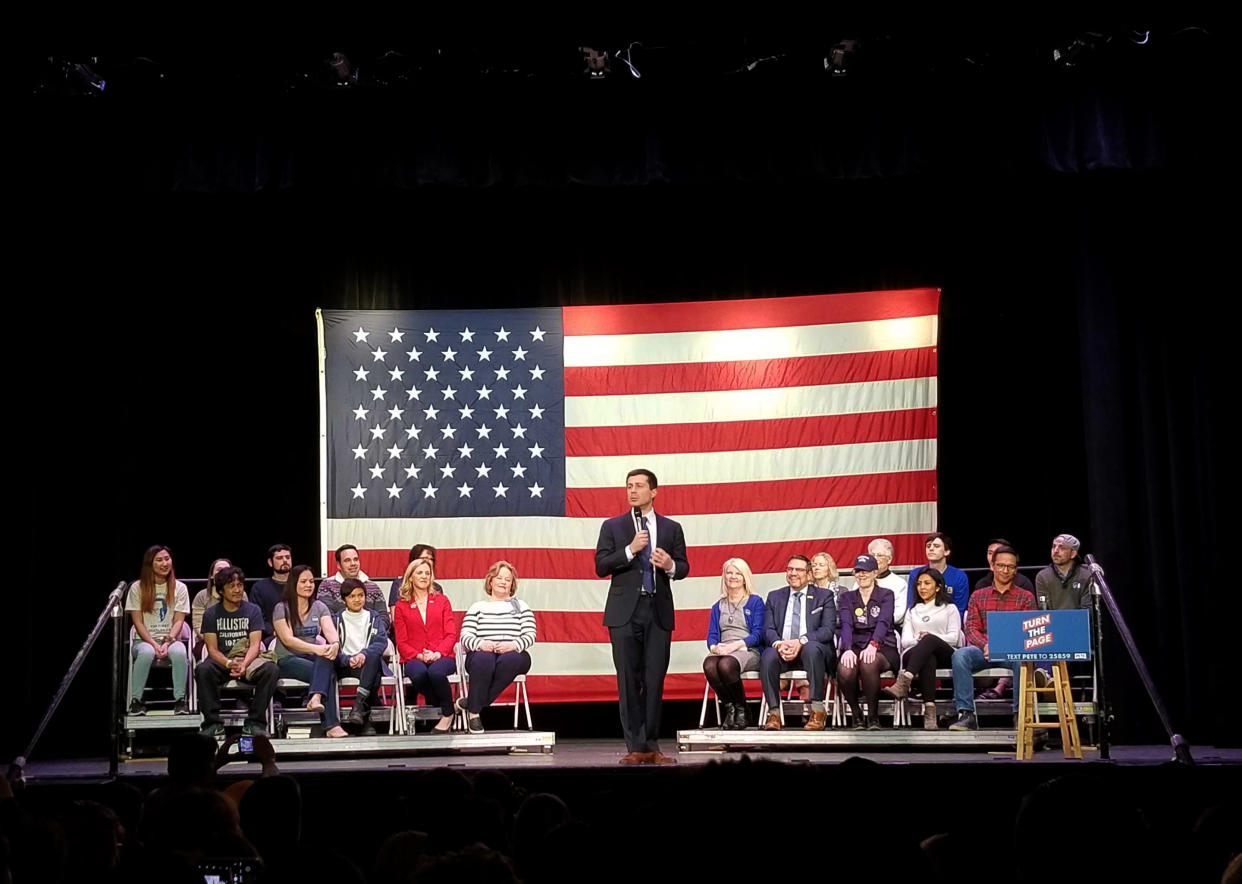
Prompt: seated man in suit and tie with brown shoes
<box><xmin>759</xmin><ymin>555</ymin><xmax>837</xmax><ymax>730</ymax></box>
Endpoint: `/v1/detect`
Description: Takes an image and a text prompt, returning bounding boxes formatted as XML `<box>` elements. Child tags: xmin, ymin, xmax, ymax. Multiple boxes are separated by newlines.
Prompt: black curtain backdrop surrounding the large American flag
<box><xmin>12</xmin><ymin>36</ymin><xmax>1237</xmax><ymax>756</ymax></box>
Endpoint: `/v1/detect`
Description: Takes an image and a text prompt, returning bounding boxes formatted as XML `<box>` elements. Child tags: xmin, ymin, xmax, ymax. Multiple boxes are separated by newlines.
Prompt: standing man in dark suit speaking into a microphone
<box><xmin>595</xmin><ymin>469</ymin><xmax>691</xmax><ymax>765</ymax></box>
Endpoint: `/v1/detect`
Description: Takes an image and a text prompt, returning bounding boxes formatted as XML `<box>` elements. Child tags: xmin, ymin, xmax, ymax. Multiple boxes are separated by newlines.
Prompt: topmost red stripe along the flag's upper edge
<box><xmin>561</xmin><ymin>288</ymin><xmax>940</xmax><ymax>336</ymax></box>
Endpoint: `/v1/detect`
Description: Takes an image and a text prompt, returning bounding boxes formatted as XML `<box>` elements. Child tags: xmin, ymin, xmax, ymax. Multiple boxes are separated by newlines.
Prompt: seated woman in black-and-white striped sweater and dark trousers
<box><xmin>457</xmin><ymin>561</ymin><xmax>535</xmax><ymax>734</ymax></box>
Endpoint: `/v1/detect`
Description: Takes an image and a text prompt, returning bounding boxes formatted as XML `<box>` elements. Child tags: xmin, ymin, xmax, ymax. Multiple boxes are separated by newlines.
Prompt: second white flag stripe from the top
<box><xmin>565</xmin><ymin>377</ymin><xmax>936</xmax><ymax>427</ymax></box>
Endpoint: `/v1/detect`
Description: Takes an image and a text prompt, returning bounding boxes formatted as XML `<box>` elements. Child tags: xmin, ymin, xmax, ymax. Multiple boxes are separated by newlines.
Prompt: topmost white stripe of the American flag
<box><xmin>565</xmin><ymin>317</ymin><xmax>936</xmax><ymax>368</ymax></box>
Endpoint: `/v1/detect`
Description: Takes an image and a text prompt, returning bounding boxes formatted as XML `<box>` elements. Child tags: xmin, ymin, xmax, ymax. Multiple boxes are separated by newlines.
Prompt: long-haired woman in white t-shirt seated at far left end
<box><xmin>125</xmin><ymin>545</ymin><xmax>190</xmax><ymax>715</ymax></box>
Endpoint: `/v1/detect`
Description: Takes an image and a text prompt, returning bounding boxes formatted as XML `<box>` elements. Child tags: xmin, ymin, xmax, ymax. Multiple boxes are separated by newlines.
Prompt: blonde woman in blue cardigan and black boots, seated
<box><xmin>703</xmin><ymin>559</ymin><xmax>764</xmax><ymax>730</ymax></box>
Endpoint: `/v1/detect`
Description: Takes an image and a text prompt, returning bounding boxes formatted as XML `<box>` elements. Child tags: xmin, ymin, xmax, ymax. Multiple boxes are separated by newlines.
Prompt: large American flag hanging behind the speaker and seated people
<box><xmin>319</xmin><ymin>288</ymin><xmax>939</xmax><ymax>701</ymax></box>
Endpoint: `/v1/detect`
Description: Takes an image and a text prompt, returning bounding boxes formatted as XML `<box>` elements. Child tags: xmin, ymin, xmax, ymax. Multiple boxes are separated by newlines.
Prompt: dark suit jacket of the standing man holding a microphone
<box><xmin>595</xmin><ymin>513</ymin><xmax>691</xmax><ymax>632</ymax></box>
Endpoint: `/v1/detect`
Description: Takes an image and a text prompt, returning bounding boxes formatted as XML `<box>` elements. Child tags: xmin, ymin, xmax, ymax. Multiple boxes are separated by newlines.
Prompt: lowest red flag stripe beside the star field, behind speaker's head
<box><xmin>565</xmin><ymin>469</ymin><xmax>936</xmax><ymax>518</ymax></box>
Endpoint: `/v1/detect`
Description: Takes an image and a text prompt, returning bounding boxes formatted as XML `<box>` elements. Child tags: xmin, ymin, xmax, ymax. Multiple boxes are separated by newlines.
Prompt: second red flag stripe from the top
<box><xmin>565</xmin><ymin>346</ymin><xmax>936</xmax><ymax>396</ymax></box>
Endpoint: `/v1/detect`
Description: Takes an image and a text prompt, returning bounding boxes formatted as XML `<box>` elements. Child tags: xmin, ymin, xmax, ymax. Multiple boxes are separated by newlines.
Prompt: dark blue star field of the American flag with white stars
<box><xmin>320</xmin><ymin>308</ymin><xmax>565</xmax><ymax>519</ymax></box>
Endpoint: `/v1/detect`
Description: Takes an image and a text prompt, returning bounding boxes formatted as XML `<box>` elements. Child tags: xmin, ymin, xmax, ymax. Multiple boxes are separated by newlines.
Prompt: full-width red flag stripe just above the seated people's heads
<box><xmin>350</xmin><ymin>531</ymin><xmax>927</xmax><ymax>581</ymax></box>
